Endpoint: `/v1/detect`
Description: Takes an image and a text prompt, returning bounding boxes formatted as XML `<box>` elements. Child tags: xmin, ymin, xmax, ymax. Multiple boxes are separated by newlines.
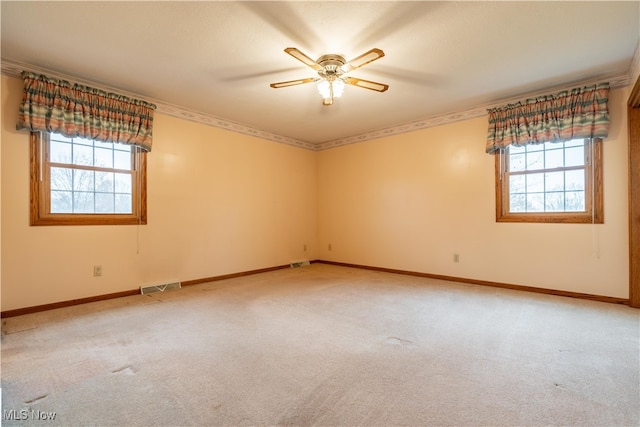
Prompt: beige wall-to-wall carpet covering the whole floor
<box><xmin>2</xmin><ymin>264</ymin><xmax>640</xmax><ymax>426</ymax></box>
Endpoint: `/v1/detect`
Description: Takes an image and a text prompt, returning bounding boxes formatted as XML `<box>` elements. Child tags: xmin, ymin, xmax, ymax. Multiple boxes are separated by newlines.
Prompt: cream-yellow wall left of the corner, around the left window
<box><xmin>1</xmin><ymin>76</ymin><xmax>317</xmax><ymax>310</ymax></box>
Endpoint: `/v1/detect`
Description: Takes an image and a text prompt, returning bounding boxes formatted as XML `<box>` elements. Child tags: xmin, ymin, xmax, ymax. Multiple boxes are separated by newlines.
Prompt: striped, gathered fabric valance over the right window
<box><xmin>486</xmin><ymin>83</ymin><xmax>609</xmax><ymax>154</ymax></box>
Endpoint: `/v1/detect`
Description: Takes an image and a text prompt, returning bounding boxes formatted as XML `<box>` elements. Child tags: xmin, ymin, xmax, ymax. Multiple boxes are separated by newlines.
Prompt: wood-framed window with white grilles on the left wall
<box><xmin>31</xmin><ymin>132</ymin><xmax>147</xmax><ymax>225</ymax></box>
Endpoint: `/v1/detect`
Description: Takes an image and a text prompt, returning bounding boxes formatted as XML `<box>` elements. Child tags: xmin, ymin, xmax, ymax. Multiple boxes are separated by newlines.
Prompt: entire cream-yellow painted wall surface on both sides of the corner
<box><xmin>0</xmin><ymin>76</ymin><xmax>628</xmax><ymax>311</ymax></box>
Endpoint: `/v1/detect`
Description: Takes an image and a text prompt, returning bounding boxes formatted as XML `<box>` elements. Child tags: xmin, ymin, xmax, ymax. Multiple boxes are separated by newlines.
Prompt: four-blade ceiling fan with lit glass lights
<box><xmin>269</xmin><ymin>47</ymin><xmax>389</xmax><ymax>105</ymax></box>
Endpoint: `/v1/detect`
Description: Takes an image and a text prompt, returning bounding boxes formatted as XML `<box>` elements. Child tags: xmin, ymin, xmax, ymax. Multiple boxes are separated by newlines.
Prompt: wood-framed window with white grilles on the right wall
<box><xmin>495</xmin><ymin>138</ymin><xmax>604</xmax><ymax>224</ymax></box>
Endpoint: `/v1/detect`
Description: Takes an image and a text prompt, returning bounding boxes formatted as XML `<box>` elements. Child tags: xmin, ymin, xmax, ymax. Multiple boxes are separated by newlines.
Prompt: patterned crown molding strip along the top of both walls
<box><xmin>1</xmin><ymin>57</ymin><xmax>640</xmax><ymax>151</ymax></box>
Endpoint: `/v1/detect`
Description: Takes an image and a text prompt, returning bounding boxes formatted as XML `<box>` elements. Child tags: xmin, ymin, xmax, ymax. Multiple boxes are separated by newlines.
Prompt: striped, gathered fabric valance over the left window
<box><xmin>17</xmin><ymin>71</ymin><xmax>156</xmax><ymax>151</ymax></box>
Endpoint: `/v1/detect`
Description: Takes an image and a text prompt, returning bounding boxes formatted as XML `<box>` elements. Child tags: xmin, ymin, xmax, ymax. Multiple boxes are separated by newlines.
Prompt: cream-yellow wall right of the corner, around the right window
<box><xmin>318</xmin><ymin>89</ymin><xmax>628</xmax><ymax>298</ymax></box>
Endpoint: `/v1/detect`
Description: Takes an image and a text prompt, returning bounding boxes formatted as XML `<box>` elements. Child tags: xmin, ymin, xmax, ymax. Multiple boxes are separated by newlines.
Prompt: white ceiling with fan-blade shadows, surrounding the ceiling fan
<box><xmin>1</xmin><ymin>0</ymin><xmax>640</xmax><ymax>147</ymax></box>
